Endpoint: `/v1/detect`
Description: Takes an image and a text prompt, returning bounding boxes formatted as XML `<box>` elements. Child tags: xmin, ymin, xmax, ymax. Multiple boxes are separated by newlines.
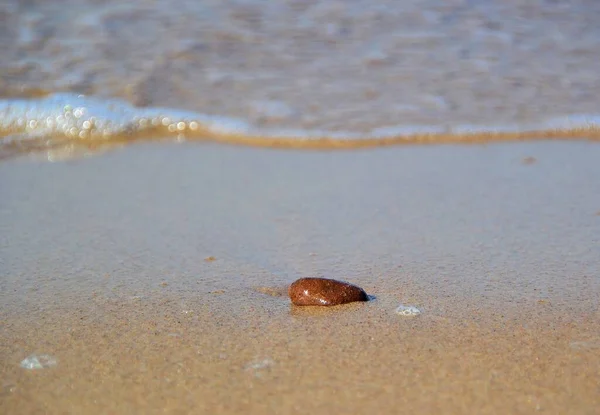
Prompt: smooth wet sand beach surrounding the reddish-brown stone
<box><xmin>0</xmin><ymin>142</ymin><xmax>600</xmax><ymax>414</ymax></box>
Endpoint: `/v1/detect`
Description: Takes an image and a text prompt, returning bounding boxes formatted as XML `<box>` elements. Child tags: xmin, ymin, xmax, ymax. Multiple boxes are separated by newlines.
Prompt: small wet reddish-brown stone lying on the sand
<box><xmin>288</xmin><ymin>278</ymin><xmax>369</xmax><ymax>306</ymax></box>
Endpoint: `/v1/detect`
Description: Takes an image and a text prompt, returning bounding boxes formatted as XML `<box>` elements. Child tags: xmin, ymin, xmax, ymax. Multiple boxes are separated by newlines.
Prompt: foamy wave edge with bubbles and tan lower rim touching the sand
<box><xmin>0</xmin><ymin>94</ymin><xmax>600</xmax><ymax>159</ymax></box>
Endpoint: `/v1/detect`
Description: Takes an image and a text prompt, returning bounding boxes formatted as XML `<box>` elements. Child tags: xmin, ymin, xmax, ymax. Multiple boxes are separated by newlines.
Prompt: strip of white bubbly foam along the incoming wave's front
<box><xmin>0</xmin><ymin>93</ymin><xmax>600</xmax><ymax>148</ymax></box>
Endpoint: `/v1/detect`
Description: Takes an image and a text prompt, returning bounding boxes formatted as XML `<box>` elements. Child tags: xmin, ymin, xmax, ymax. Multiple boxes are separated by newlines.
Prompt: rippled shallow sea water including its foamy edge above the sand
<box><xmin>0</xmin><ymin>0</ymin><xmax>600</xmax><ymax>160</ymax></box>
